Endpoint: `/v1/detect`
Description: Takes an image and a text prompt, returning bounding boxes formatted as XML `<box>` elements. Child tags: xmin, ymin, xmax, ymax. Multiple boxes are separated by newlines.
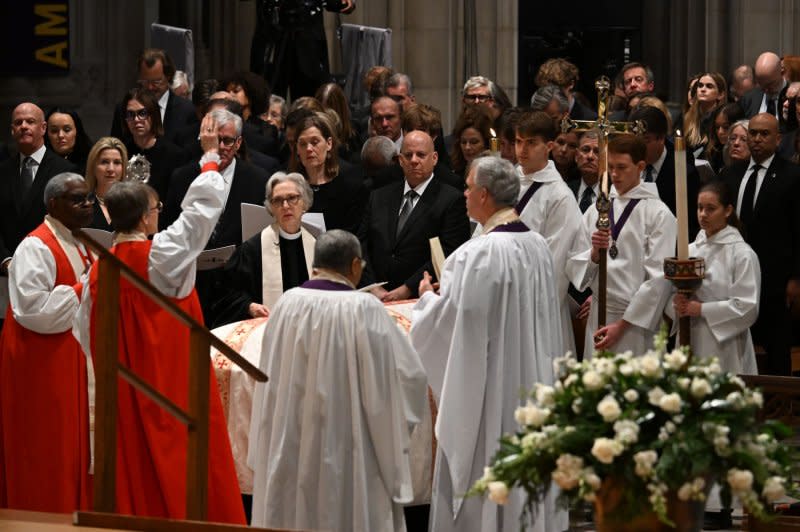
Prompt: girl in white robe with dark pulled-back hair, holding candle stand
<box><xmin>668</xmin><ymin>182</ymin><xmax>761</xmax><ymax>375</ymax></box>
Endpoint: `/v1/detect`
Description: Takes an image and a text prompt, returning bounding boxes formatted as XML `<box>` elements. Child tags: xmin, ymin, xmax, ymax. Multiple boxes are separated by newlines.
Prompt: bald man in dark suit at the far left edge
<box><xmin>0</xmin><ymin>102</ymin><xmax>76</xmax><ymax>276</ymax></box>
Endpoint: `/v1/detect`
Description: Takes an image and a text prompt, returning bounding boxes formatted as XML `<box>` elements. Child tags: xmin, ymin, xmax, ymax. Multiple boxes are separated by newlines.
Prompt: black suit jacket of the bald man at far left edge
<box><xmin>0</xmin><ymin>150</ymin><xmax>76</xmax><ymax>260</ymax></box>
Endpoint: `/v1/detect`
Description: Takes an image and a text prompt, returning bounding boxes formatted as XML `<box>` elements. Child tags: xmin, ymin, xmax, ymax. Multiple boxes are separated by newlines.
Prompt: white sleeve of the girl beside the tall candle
<box><xmin>700</xmin><ymin>245</ymin><xmax>761</xmax><ymax>343</ymax></box>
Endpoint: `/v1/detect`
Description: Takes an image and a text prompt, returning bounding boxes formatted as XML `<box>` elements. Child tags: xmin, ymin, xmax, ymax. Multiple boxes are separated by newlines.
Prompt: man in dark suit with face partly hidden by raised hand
<box><xmin>162</xmin><ymin>109</ymin><xmax>267</xmax><ymax>324</ymax></box>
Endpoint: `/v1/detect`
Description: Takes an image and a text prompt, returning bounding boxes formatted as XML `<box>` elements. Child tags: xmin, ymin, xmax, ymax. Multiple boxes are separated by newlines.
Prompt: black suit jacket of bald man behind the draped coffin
<box><xmin>359</xmin><ymin>179</ymin><xmax>469</xmax><ymax>296</ymax></box>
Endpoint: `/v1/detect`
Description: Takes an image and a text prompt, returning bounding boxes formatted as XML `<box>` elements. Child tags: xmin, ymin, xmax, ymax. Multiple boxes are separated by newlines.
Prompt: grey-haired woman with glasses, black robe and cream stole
<box><xmin>216</xmin><ymin>172</ymin><xmax>316</xmax><ymax>326</ymax></box>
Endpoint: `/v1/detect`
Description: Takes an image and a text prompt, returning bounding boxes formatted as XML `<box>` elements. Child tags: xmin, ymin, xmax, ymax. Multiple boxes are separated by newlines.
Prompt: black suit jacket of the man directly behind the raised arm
<box><xmin>161</xmin><ymin>159</ymin><xmax>267</xmax><ymax>249</ymax></box>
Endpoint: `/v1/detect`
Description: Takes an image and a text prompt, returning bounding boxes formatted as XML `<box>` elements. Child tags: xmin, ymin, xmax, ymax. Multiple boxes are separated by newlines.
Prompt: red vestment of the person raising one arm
<box><xmin>89</xmin><ymin>241</ymin><xmax>245</xmax><ymax>524</ymax></box>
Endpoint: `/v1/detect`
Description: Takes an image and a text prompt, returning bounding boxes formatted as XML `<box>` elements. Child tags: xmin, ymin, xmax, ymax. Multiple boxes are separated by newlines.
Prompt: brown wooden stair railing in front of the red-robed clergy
<box><xmin>73</xmin><ymin>230</ymin><xmax>267</xmax><ymax>530</ymax></box>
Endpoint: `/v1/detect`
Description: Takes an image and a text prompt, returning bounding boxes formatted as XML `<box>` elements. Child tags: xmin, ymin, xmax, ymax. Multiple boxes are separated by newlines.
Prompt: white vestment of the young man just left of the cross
<box><xmin>519</xmin><ymin>161</ymin><xmax>582</xmax><ymax>353</ymax></box>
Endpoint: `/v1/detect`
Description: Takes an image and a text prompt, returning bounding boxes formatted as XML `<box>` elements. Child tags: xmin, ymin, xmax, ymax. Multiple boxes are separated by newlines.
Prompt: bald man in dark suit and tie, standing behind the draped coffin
<box><xmin>359</xmin><ymin>131</ymin><xmax>469</xmax><ymax>301</ymax></box>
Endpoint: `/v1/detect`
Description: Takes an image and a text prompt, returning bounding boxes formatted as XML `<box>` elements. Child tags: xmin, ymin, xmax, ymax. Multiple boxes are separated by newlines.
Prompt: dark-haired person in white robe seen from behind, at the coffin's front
<box><xmin>248</xmin><ymin>230</ymin><xmax>427</xmax><ymax>532</ymax></box>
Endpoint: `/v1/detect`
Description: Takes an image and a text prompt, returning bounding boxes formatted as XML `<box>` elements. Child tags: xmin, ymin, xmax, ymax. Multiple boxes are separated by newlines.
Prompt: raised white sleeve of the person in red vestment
<box><xmin>147</xmin><ymin>157</ymin><xmax>225</xmax><ymax>297</ymax></box>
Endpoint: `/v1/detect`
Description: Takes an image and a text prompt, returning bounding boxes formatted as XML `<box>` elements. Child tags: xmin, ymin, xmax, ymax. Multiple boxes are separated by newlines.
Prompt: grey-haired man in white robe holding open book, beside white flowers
<box><xmin>411</xmin><ymin>157</ymin><xmax>568</xmax><ymax>532</ymax></box>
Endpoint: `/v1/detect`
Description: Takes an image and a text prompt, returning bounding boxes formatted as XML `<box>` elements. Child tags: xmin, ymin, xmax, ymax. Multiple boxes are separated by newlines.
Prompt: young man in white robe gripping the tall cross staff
<box><xmin>567</xmin><ymin>135</ymin><xmax>677</xmax><ymax>358</ymax></box>
